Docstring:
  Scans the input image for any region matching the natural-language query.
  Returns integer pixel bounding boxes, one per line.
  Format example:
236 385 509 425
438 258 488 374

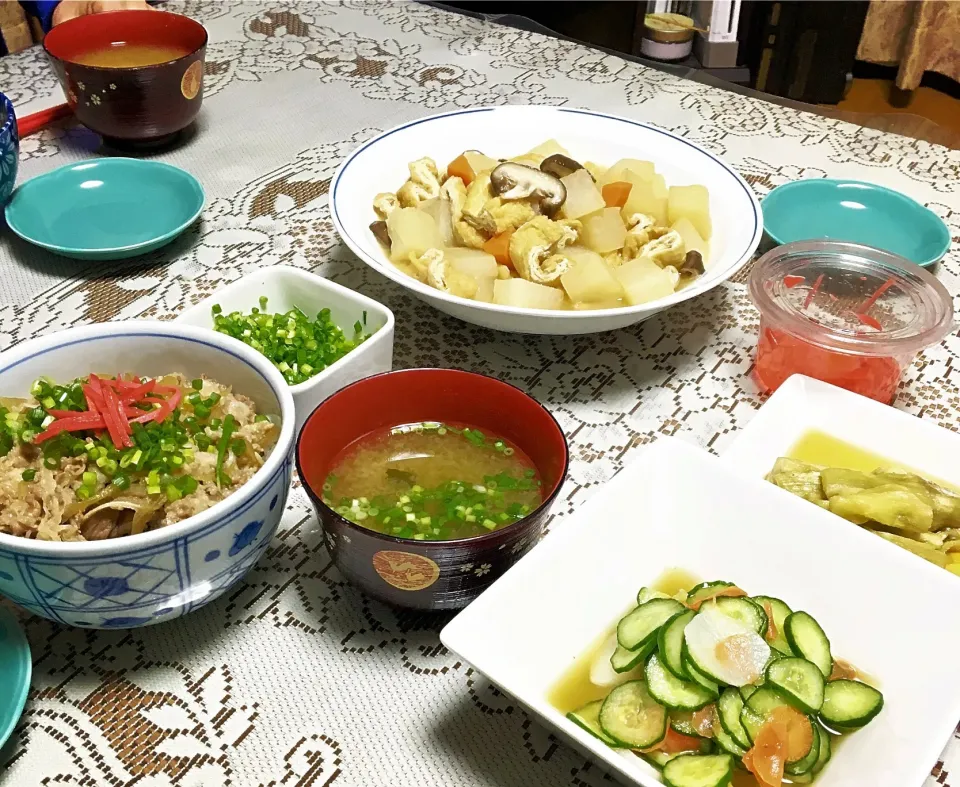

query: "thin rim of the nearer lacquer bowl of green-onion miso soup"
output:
293 366 570 549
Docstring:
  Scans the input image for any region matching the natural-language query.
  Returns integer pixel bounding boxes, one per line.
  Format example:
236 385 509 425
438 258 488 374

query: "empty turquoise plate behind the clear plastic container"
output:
760 179 950 266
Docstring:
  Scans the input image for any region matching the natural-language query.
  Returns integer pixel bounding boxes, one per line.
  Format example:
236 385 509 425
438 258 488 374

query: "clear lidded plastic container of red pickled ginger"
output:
750 241 953 403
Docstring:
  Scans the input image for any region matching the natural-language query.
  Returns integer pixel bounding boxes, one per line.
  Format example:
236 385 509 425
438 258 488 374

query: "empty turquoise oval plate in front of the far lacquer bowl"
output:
6 158 204 260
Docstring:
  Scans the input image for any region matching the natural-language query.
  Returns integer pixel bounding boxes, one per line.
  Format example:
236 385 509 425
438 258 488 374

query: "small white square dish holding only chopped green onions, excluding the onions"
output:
176 265 394 434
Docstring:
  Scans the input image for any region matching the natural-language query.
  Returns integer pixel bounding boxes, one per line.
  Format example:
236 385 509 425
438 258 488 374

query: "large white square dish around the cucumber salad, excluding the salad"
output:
440 438 960 787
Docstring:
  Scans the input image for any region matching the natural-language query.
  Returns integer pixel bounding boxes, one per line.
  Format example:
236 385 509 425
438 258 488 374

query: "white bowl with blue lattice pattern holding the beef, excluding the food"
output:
0 321 295 628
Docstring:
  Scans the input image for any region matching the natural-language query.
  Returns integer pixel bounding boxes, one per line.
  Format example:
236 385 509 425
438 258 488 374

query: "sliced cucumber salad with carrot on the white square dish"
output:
567 582 883 787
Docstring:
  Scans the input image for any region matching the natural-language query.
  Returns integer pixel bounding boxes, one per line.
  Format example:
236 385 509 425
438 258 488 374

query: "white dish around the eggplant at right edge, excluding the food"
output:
723 374 960 490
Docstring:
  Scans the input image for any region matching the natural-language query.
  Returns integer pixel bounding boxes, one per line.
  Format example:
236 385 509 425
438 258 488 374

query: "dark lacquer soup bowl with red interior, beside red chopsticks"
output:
43 10 207 144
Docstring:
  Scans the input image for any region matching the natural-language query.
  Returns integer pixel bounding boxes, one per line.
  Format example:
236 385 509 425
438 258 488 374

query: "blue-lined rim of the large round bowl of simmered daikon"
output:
330 104 763 321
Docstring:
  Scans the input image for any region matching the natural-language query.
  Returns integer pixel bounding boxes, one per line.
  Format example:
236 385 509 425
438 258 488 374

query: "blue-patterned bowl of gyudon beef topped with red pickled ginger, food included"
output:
0 322 294 628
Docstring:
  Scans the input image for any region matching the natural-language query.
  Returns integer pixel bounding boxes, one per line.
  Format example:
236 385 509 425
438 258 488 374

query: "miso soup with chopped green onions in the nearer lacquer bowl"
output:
323 422 543 541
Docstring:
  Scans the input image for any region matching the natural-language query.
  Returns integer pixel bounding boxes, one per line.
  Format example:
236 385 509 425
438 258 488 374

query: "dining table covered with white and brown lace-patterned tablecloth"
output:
0 0 960 787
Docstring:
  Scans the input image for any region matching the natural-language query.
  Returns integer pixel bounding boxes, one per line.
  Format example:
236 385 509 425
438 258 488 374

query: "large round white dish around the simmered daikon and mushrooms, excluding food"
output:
330 106 763 334
